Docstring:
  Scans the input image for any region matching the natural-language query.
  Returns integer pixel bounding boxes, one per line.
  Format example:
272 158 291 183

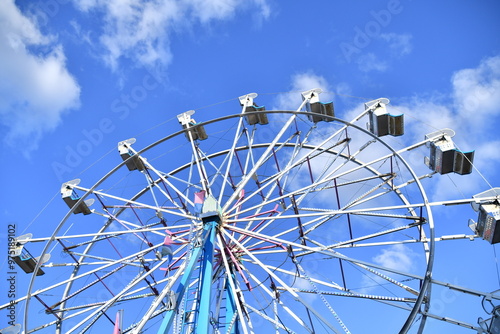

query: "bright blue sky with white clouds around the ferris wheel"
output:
0 0 500 332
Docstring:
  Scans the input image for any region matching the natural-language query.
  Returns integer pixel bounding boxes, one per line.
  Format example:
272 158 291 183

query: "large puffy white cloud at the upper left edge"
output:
0 0 80 154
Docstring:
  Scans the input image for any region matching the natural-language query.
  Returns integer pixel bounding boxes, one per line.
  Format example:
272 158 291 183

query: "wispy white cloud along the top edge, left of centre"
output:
72 0 270 70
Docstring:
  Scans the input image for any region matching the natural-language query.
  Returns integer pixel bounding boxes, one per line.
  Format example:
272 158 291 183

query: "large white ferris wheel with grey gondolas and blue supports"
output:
0 89 500 334
